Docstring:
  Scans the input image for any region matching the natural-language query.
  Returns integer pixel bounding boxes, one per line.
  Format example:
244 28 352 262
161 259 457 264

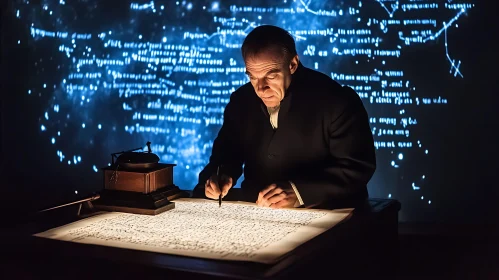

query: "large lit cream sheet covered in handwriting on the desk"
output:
35 198 353 263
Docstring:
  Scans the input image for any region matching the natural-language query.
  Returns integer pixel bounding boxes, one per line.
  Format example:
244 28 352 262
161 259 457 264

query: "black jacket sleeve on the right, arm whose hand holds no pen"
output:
292 87 376 205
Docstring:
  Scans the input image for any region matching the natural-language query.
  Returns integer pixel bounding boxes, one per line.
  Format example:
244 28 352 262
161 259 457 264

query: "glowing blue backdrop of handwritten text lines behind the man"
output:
6 0 488 223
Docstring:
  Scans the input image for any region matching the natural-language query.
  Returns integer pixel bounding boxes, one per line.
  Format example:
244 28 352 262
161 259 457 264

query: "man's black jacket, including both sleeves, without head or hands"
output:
194 63 376 205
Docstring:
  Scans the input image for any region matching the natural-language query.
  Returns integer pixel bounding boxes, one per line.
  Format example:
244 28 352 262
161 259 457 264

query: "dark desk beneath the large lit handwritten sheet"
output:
6 194 400 279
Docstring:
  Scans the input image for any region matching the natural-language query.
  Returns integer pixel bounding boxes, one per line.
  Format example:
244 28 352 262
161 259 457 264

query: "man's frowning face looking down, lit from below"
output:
245 50 298 107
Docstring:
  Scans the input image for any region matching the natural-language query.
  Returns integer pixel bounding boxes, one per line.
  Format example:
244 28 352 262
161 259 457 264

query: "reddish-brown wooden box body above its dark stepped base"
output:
103 163 175 194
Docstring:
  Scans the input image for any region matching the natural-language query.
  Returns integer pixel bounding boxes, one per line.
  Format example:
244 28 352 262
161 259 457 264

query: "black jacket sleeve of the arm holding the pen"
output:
193 92 243 198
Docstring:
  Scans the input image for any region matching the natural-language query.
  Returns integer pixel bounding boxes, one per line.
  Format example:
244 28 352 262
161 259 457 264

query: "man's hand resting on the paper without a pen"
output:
256 184 298 208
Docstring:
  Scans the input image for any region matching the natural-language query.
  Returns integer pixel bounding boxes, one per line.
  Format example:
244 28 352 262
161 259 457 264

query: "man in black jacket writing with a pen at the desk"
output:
193 25 376 208
